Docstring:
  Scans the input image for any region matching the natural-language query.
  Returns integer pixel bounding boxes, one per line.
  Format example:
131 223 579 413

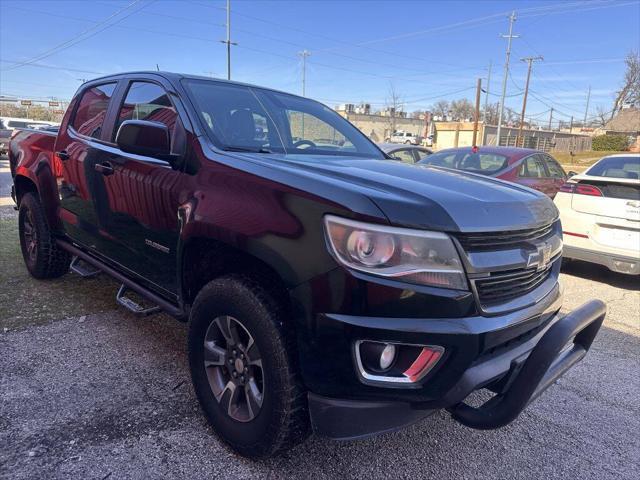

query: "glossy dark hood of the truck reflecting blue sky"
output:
251 154 558 232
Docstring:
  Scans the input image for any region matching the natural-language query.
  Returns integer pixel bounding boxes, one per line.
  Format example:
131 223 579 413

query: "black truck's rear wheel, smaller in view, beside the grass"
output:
18 192 71 279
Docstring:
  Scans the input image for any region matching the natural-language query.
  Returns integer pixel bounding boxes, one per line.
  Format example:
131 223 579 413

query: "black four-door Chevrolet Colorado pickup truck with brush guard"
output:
9 72 605 457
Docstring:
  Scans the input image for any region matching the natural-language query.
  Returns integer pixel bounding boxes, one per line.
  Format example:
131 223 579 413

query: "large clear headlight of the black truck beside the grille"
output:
324 215 467 290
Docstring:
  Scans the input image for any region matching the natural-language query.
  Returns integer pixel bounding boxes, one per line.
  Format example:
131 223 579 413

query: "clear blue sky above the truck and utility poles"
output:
0 0 640 124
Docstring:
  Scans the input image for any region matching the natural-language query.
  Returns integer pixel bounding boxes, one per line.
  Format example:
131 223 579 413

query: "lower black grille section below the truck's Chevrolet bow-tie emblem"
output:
473 262 554 306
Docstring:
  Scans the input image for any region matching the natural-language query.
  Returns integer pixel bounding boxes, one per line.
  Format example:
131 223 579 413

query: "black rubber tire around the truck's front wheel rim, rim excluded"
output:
188 275 310 458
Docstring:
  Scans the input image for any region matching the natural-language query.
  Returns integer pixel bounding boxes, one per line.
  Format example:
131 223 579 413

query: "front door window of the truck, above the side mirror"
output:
113 82 179 139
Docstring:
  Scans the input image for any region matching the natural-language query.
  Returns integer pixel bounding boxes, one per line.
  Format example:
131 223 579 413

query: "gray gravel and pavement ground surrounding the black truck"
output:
0 156 640 480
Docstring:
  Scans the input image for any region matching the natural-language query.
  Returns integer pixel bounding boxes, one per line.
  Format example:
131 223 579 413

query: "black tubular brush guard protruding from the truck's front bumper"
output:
447 300 606 430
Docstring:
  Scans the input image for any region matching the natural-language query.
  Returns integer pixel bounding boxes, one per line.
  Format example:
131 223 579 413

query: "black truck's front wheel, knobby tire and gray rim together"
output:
189 275 310 458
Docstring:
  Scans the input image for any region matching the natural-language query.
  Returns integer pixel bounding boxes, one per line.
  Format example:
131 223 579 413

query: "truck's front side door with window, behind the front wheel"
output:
93 79 186 294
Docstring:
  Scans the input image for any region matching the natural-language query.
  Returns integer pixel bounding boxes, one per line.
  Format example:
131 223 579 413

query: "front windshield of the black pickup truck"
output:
184 79 385 159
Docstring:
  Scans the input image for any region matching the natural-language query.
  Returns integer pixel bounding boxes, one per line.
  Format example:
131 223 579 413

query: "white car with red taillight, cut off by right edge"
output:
554 153 640 275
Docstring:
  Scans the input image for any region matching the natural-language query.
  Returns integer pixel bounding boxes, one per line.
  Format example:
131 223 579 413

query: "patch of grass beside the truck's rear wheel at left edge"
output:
0 207 118 332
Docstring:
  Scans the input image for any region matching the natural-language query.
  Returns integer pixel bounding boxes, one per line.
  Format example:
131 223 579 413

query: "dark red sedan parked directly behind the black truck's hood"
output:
420 147 567 198
